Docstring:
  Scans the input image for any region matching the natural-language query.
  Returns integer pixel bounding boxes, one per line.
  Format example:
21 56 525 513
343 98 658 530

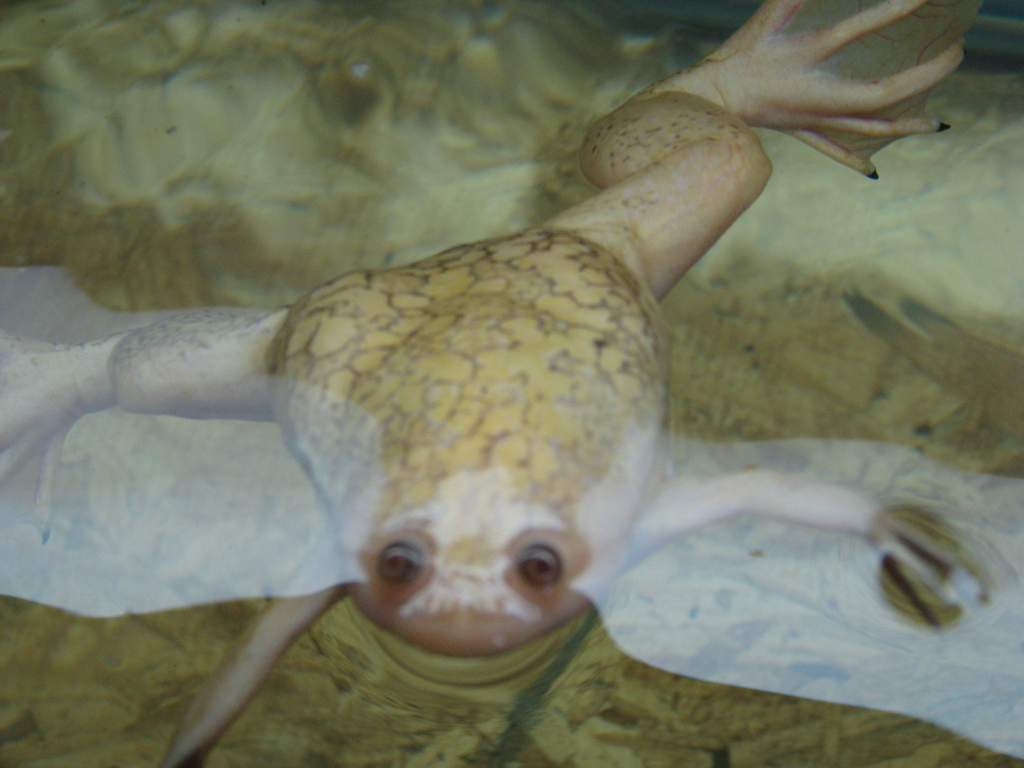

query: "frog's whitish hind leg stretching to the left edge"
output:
0 309 285 538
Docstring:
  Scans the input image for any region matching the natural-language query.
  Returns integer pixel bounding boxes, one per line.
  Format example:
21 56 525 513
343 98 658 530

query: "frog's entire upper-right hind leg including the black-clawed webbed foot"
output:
549 0 979 296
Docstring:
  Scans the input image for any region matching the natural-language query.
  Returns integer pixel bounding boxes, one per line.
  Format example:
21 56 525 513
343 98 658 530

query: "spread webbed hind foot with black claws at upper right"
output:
679 0 980 178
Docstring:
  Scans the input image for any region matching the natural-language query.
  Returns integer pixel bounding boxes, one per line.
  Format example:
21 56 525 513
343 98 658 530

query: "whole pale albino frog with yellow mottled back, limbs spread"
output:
0 0 979 766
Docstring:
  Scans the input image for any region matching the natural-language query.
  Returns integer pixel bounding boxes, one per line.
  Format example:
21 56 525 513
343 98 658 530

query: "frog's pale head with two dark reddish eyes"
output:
353 469 591 655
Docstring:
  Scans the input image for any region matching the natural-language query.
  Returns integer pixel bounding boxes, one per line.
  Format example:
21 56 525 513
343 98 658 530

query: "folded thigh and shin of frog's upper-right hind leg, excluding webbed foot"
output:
547 93 771 297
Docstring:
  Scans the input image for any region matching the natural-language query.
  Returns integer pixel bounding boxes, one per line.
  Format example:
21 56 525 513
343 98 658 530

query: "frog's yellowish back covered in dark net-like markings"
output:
271 230 666 524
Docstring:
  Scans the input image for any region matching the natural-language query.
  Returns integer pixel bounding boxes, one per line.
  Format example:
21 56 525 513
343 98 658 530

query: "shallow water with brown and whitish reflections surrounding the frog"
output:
0 0 1024 768
